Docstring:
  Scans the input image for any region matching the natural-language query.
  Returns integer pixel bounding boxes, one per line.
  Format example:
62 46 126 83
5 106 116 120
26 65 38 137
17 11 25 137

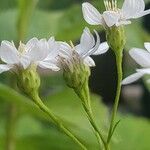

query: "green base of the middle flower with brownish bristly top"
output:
62 53 90 90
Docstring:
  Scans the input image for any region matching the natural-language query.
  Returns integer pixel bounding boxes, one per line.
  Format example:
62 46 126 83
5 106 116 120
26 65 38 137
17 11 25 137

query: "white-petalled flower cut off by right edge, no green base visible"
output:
122 42 150 85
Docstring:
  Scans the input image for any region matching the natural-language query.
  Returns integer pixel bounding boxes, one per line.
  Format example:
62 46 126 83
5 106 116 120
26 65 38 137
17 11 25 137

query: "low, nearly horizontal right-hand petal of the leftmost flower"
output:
38 61 60 71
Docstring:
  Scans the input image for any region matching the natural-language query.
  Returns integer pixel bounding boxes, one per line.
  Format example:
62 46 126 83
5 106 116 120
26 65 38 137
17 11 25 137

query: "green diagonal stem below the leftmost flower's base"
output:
34 96 87 150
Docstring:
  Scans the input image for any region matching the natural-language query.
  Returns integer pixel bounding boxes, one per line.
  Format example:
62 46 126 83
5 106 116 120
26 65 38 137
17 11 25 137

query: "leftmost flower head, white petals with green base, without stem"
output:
0 37 59 100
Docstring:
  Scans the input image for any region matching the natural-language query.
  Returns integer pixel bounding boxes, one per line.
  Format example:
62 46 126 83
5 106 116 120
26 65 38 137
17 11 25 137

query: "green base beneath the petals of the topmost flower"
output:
106 26 126 54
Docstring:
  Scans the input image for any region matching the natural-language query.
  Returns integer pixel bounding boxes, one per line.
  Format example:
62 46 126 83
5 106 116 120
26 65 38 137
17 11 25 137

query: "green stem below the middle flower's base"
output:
75 81 107 150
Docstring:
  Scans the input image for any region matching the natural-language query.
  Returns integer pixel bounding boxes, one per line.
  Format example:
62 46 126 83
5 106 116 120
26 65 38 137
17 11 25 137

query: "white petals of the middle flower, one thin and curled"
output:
60 27 109 67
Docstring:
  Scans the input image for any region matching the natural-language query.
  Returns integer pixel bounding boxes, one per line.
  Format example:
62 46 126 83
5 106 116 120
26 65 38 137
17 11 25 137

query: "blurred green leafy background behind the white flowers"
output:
0 0 150 150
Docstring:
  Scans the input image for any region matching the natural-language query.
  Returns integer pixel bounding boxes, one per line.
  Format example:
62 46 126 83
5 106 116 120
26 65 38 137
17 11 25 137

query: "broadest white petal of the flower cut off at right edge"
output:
129 48 150 67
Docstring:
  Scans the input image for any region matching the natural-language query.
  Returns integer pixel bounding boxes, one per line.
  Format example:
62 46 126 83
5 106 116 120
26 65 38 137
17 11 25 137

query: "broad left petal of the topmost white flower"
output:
82 2 103 25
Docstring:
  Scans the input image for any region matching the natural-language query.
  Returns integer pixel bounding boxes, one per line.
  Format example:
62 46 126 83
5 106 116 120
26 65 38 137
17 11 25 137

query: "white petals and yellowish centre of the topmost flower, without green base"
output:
82 0 150 27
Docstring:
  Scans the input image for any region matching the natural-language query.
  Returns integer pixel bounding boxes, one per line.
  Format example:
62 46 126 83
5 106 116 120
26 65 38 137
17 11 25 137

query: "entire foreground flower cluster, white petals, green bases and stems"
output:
0 0 150 150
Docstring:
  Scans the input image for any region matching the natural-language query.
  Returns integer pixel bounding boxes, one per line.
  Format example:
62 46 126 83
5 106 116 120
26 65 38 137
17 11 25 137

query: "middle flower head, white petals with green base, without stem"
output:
59 28 109 90
